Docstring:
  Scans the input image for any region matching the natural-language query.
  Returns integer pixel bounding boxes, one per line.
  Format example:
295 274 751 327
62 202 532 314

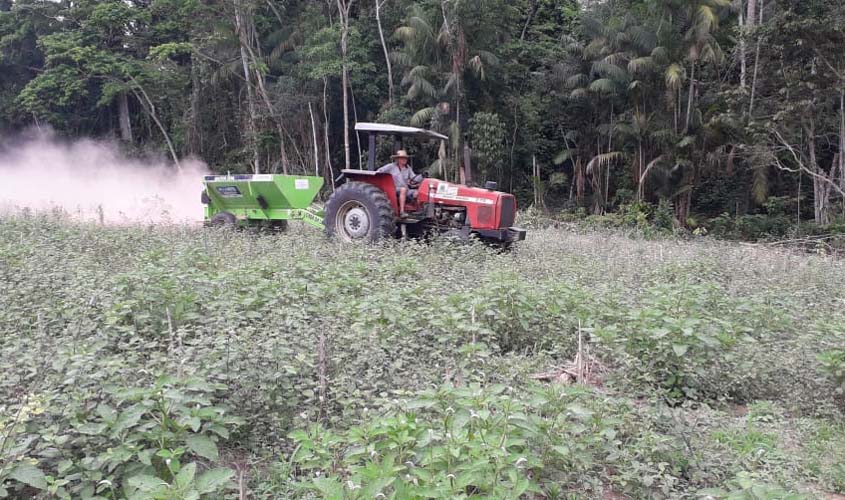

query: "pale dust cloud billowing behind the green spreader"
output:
0 133 208 224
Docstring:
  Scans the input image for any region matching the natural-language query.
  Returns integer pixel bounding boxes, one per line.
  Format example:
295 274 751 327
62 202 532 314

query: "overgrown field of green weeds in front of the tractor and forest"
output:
0 217 845 499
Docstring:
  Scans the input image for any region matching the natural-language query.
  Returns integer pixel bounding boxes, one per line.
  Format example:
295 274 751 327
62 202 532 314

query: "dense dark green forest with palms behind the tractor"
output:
0 0 845 226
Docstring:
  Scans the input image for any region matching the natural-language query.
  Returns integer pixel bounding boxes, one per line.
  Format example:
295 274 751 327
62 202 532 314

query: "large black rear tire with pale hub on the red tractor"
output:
324 182 396 242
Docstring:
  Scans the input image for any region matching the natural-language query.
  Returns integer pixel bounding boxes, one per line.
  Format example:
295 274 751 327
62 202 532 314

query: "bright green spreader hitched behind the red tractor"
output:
202 174 324 229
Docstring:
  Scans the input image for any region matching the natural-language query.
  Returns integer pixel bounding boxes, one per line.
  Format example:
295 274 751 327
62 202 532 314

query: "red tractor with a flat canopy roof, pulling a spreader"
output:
323 123 526 245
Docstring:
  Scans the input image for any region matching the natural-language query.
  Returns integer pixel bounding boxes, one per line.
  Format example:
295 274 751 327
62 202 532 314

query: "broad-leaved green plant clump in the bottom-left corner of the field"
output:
0 376 243 499
